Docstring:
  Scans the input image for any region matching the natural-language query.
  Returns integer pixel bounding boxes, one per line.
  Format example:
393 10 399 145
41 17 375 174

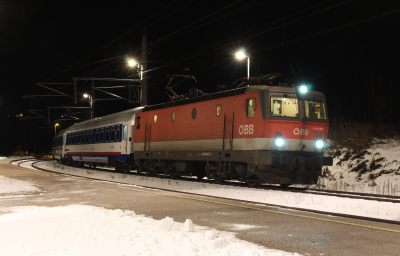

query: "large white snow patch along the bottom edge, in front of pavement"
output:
0 205 299 256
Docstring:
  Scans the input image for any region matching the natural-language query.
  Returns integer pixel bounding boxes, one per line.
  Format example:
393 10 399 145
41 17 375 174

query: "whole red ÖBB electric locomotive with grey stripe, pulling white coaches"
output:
133 74 333 185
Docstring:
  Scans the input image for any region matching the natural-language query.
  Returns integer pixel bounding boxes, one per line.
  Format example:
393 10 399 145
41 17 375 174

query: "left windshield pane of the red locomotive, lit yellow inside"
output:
271 97 299 117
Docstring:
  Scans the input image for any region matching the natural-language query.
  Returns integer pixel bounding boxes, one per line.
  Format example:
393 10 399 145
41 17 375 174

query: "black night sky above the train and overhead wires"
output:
0 0 400 154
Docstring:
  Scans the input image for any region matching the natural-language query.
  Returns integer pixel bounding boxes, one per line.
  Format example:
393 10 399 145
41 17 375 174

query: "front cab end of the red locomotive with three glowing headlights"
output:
249 86 333 185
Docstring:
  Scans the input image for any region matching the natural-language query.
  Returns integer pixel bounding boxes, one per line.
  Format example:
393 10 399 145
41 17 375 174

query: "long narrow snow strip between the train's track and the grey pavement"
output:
37 162 400 221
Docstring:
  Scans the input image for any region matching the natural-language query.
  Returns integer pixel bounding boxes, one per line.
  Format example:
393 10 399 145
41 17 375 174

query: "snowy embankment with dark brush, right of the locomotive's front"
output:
316 140 400 196
